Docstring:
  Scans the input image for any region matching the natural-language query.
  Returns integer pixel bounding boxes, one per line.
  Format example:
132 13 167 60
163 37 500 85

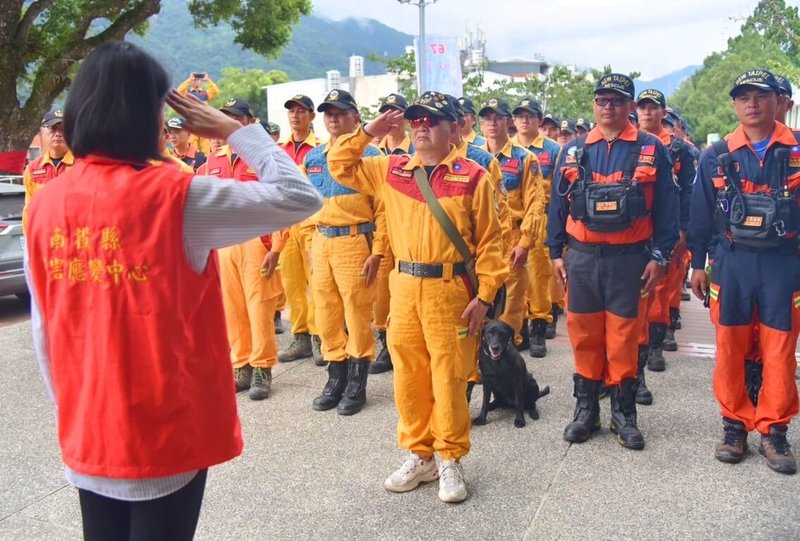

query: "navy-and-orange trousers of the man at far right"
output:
709 246 800 434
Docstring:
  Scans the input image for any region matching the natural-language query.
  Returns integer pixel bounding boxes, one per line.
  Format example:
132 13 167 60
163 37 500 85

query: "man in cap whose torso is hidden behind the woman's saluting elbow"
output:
278 94 325 366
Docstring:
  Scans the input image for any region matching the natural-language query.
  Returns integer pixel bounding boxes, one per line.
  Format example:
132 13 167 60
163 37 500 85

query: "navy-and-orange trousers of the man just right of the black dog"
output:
564 249 647 386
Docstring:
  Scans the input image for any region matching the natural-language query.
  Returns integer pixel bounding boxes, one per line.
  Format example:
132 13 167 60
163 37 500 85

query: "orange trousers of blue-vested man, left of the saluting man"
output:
311 231 376 362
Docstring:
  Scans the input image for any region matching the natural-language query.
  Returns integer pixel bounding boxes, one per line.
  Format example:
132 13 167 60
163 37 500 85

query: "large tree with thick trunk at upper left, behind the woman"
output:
0 0 311 160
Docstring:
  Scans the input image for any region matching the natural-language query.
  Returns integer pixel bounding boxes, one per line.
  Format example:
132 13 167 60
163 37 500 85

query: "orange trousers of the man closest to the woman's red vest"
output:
218 238 283 368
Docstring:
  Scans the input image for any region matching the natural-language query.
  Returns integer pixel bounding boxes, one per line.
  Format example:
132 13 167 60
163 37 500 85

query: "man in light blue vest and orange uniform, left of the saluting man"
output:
303 90 386 415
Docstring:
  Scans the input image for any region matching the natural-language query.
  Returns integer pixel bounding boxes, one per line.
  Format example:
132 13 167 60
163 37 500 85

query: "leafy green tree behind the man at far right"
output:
669 0 800 142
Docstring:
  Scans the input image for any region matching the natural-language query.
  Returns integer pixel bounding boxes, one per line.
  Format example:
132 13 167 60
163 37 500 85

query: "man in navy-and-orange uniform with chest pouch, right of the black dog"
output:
547 73 678 449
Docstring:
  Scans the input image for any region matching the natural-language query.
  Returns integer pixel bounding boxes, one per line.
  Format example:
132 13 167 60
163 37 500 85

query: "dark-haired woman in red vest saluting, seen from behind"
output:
26 42 322 540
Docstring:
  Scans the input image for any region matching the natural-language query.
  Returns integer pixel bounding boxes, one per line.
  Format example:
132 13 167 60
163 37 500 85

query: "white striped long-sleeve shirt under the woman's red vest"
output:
25 124 322 501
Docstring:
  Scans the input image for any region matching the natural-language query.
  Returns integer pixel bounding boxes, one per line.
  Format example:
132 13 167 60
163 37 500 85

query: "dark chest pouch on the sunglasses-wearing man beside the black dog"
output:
569 182 649 233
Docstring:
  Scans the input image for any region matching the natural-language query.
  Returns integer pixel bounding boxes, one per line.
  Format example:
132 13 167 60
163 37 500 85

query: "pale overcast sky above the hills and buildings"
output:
313 0 800 80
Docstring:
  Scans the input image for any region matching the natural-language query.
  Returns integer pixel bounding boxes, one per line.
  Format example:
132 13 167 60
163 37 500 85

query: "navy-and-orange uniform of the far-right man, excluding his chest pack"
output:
687 122 800 434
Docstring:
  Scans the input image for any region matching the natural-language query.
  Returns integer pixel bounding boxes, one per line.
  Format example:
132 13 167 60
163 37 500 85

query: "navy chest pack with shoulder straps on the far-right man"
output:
713 140 800 251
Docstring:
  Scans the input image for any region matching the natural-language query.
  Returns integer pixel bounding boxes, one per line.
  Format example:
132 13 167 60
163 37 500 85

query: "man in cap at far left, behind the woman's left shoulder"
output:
22 109 75 225
